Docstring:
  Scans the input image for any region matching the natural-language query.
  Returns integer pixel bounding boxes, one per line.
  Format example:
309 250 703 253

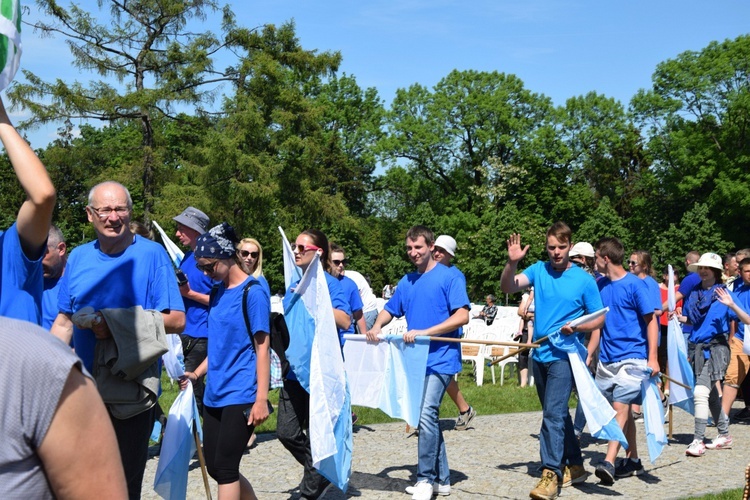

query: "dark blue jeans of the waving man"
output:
534 359 583 478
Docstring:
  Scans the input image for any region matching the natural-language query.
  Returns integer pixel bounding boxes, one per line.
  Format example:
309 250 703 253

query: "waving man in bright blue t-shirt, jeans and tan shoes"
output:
500 222 604 499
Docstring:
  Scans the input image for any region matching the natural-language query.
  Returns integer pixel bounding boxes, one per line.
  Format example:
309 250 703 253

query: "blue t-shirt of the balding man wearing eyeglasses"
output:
57 235 185 373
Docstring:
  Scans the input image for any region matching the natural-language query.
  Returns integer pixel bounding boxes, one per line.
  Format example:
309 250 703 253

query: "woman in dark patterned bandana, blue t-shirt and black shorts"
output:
180 223 271 499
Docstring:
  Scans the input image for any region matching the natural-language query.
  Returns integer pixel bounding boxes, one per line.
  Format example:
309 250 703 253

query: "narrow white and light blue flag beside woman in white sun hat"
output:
667 266 695 415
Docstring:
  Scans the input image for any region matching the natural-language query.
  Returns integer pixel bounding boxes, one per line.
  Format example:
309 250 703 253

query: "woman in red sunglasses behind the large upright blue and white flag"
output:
276 229 352 498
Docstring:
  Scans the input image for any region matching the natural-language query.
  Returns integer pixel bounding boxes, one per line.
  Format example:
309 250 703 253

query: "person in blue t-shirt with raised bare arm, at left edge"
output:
0 100 56 325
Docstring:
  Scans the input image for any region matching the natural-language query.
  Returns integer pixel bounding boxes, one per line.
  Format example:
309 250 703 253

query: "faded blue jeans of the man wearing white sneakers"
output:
417 373 452 484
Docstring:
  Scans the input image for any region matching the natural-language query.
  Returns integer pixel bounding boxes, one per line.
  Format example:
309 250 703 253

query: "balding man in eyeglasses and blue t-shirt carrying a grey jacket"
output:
50 181 185 499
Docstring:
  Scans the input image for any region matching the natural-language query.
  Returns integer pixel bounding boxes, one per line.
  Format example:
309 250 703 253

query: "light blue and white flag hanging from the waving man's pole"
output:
548 330 628 449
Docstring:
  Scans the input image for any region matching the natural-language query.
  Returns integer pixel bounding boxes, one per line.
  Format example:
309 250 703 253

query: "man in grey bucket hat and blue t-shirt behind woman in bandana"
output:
172 207 213 414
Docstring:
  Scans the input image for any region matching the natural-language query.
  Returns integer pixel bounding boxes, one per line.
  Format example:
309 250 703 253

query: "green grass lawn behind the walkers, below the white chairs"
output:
159 363 575 432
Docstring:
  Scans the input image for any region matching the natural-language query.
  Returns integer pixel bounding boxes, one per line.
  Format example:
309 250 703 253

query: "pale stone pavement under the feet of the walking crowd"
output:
143 405 750 500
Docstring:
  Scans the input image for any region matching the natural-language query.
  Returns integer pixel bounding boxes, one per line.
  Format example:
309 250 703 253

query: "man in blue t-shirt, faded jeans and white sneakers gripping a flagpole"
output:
367 226 469 500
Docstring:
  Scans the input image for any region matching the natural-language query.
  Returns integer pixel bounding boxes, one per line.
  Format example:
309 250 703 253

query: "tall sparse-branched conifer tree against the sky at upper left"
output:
8 0 234 221
